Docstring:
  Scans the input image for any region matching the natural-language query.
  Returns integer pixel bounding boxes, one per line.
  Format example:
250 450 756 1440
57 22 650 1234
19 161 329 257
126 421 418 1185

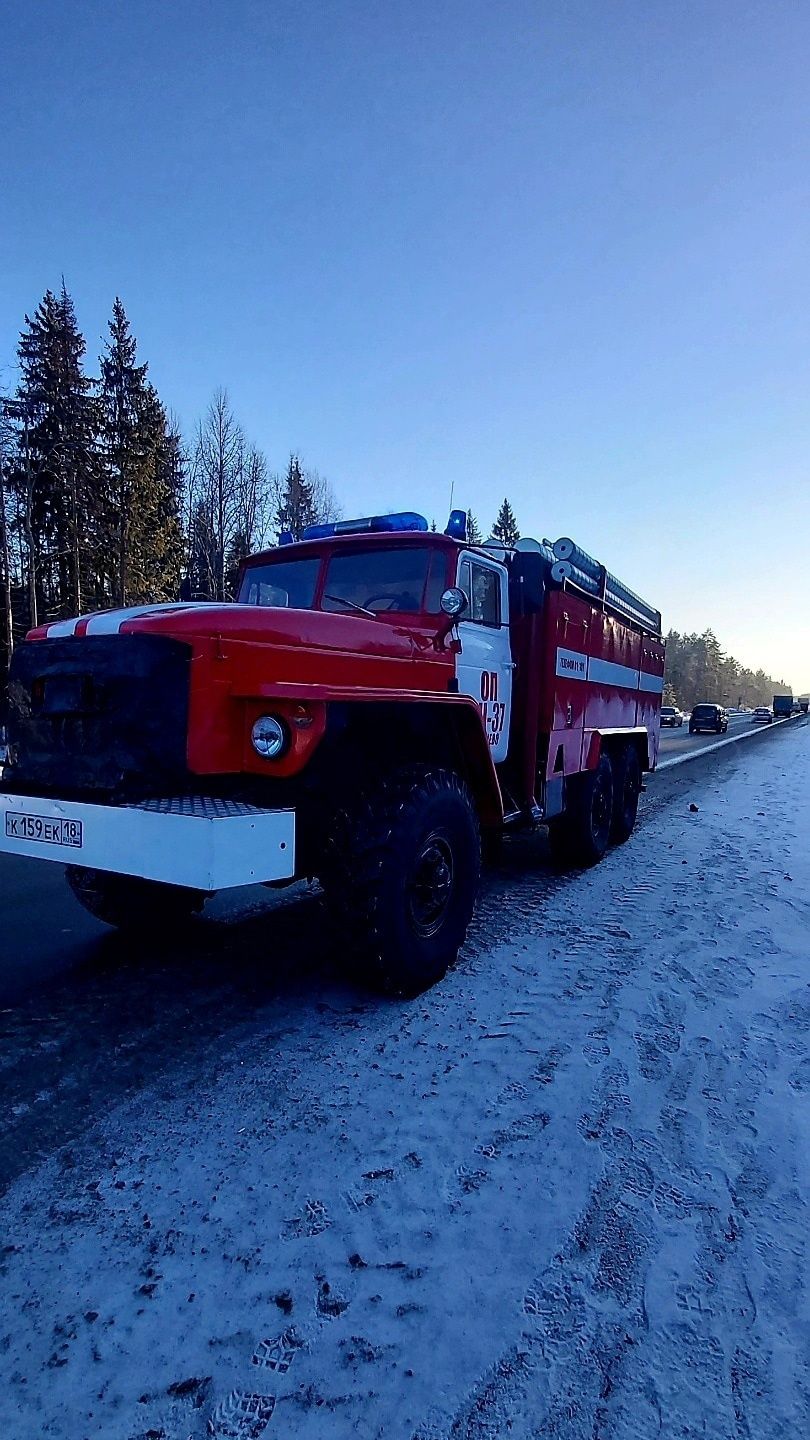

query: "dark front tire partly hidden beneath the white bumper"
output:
65 865 205 933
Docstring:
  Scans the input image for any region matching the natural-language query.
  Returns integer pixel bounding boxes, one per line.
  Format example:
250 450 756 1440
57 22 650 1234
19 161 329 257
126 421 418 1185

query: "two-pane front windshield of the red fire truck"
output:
239 546 445 615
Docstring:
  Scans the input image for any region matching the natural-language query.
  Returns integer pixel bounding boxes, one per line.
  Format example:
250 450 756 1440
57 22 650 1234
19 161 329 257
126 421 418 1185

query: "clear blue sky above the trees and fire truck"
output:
0 0 810 690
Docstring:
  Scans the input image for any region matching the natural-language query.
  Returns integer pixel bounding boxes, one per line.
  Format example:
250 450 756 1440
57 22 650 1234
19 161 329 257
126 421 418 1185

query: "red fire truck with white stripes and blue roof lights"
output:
0 511 664 994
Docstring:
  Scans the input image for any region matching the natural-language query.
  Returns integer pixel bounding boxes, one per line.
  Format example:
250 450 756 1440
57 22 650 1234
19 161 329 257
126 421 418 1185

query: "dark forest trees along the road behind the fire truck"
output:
0 284 788 706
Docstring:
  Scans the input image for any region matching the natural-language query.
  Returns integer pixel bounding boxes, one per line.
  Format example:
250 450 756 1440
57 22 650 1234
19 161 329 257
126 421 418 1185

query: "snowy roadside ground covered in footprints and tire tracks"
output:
0 726 810 1440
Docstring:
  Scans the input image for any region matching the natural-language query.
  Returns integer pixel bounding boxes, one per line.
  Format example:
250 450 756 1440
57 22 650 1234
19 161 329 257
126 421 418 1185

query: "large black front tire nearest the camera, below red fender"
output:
320 765 481 996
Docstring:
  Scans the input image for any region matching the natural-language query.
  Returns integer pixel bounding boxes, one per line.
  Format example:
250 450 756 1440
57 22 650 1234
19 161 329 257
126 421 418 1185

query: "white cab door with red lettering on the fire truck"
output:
455 554 515 765
